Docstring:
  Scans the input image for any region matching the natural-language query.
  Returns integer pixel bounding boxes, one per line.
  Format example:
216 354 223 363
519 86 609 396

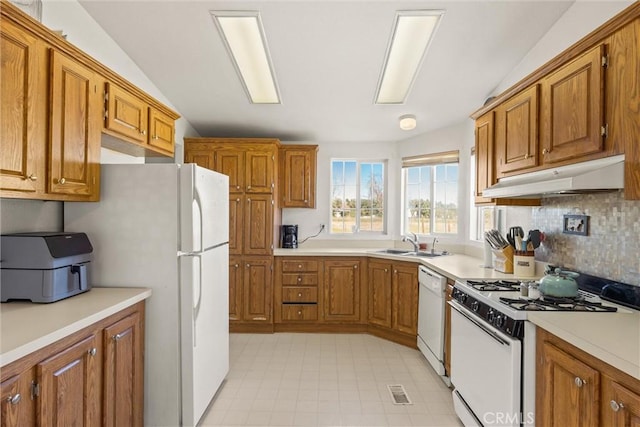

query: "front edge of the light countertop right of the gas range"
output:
528 313 640 380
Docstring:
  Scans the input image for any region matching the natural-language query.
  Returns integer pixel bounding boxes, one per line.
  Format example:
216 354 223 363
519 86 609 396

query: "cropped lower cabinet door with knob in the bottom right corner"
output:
602 378 640 427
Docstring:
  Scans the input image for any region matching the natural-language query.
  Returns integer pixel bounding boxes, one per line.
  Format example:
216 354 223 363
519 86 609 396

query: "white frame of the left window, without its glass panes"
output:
329 157 389 236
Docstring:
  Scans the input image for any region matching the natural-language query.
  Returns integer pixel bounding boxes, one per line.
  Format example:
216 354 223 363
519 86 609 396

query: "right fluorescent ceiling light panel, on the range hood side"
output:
375 10 444 104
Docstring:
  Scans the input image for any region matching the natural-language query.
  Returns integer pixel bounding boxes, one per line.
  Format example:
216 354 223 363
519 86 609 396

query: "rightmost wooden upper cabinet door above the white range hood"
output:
542 45 604 163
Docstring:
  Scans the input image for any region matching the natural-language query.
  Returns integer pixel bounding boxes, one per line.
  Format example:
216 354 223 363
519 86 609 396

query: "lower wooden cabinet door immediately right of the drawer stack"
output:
324 260 361 322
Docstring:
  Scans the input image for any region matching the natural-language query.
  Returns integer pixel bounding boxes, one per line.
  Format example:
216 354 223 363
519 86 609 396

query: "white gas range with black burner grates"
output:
449 275 635 426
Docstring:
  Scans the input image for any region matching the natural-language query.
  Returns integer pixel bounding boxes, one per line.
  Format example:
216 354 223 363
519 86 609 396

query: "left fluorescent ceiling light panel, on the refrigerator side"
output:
210 11 280 104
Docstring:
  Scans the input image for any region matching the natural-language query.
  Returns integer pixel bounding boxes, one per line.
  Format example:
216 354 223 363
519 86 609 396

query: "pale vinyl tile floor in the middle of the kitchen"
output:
199 333 462 427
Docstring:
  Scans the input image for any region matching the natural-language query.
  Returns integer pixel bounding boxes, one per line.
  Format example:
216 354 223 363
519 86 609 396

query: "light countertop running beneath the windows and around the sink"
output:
274 248 542 280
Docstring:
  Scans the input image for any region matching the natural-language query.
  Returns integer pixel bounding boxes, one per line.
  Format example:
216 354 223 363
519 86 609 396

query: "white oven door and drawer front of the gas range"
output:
449 300 522 426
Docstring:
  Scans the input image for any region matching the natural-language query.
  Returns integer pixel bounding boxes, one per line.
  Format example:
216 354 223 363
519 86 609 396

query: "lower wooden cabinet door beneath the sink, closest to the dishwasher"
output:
392 264 418 335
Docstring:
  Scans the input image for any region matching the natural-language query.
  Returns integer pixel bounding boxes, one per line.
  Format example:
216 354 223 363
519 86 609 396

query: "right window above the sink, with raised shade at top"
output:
402 151 458 234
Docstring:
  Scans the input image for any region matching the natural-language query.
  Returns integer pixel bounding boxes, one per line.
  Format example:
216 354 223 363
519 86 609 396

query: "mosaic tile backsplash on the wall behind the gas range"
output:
532 191 640 286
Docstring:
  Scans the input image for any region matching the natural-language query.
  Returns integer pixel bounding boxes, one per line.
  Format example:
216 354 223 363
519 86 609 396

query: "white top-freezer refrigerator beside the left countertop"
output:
64 164 229 426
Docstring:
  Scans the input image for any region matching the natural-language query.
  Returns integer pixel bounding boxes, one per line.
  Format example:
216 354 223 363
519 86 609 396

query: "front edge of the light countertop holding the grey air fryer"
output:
0 288 151 367
